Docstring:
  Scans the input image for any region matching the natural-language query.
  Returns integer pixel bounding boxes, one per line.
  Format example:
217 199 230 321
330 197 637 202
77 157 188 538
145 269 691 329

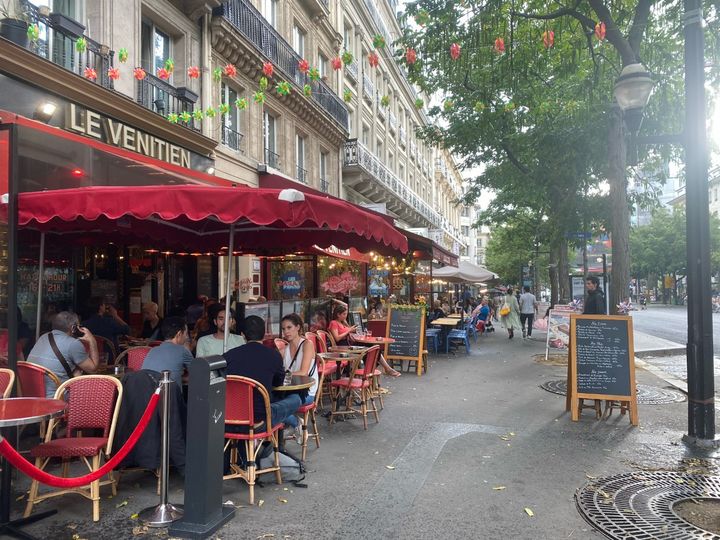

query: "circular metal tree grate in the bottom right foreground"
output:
575 472 720 540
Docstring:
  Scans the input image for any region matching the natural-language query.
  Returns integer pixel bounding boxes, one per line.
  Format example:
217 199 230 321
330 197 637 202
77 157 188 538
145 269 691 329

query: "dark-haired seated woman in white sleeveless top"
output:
280 313 318 444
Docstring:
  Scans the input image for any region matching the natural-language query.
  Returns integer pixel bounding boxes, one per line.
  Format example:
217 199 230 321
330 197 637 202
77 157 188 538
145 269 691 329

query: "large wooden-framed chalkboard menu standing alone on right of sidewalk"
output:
568 315 638 426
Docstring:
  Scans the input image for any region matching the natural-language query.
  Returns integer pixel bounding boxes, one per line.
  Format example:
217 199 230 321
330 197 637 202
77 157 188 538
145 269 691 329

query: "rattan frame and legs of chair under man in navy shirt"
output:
223 375 282 504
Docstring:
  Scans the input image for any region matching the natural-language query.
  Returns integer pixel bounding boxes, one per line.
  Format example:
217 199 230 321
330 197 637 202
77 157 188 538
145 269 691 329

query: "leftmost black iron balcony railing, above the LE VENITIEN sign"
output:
23 2 114 90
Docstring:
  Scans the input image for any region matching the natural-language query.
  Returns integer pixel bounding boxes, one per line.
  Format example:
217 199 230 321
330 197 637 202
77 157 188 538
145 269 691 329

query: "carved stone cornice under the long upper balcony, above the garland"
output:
211 17 347 146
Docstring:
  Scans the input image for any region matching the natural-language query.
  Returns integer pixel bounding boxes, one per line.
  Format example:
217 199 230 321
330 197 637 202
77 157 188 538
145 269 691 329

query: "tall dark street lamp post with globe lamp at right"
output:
615 4 718 446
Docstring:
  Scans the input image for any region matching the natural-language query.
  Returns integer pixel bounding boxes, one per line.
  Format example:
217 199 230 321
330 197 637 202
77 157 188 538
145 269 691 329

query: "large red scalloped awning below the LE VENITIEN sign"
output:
4 186 408 255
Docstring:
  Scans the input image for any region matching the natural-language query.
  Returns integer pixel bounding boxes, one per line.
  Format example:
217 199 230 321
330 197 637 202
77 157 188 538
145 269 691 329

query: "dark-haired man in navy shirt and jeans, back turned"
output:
225 315 301 429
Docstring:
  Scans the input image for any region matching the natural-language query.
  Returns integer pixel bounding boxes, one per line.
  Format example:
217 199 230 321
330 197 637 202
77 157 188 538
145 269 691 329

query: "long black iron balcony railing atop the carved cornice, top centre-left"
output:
213 0 348 131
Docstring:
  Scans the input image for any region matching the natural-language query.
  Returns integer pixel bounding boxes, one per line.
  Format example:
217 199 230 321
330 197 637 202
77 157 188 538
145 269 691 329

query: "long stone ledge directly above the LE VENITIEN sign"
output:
0 38 218 156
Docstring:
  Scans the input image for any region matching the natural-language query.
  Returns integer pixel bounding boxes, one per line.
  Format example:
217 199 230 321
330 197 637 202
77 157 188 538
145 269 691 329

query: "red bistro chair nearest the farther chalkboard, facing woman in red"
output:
330 345 380 429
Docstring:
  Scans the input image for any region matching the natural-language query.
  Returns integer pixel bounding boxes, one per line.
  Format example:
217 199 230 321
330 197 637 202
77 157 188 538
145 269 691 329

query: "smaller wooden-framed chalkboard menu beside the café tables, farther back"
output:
385 305 425 377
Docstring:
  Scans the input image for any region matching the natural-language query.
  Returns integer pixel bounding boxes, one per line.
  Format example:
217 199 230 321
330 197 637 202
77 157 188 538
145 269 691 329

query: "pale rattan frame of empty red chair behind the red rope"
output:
24 375 123 521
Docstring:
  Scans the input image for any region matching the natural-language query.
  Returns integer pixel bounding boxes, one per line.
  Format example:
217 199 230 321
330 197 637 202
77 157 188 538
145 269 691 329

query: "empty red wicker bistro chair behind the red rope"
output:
25 375 123 521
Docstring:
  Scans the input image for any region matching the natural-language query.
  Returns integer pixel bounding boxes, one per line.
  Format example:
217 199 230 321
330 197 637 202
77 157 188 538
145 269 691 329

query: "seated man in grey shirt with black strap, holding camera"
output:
28 311 99 398
